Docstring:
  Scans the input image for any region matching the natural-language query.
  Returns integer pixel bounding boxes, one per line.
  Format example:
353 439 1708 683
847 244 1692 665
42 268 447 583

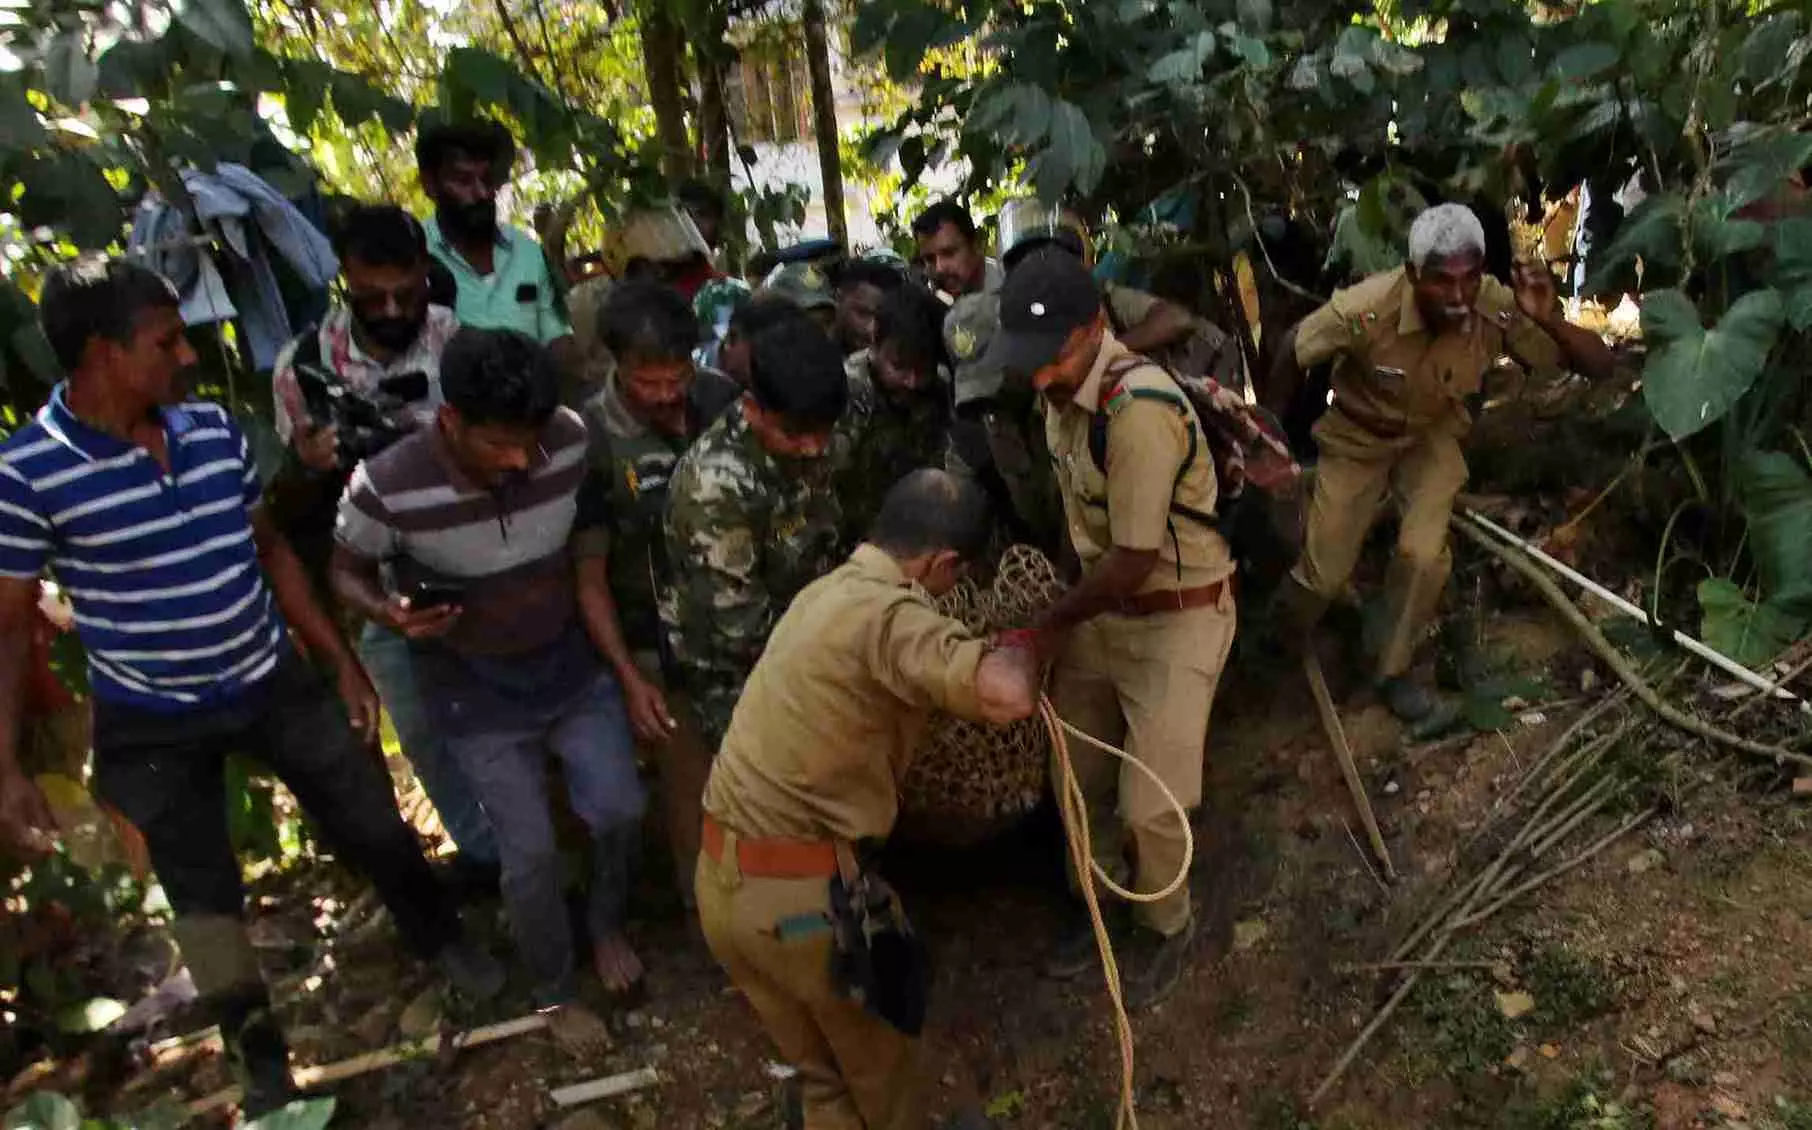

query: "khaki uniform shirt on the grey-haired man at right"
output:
1296 266 1560 445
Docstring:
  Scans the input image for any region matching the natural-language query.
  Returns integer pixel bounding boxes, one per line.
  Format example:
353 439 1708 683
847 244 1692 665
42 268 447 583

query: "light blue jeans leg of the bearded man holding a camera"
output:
359 623 498 867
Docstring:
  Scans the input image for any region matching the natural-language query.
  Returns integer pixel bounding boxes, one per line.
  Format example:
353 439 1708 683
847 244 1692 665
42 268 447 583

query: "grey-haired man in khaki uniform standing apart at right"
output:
1265 205 1614 723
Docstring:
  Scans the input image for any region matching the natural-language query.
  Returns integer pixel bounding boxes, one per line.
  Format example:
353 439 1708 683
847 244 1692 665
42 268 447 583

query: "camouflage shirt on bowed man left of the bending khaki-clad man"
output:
661 406 839 748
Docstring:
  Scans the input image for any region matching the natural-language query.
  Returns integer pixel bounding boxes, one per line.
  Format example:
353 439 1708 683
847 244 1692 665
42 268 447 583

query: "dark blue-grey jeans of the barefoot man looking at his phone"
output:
448 672 643 1007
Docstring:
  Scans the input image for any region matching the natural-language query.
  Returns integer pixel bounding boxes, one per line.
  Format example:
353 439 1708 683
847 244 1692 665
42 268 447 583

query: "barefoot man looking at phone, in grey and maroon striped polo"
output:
333 328 669 1054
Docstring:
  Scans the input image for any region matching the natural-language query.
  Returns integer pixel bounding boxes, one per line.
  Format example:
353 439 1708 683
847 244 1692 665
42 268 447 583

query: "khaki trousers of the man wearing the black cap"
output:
1051 587 1238 936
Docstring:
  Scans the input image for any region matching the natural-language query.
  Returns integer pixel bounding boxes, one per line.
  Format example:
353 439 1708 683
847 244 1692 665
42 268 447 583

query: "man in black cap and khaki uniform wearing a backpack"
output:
989 250 1236 1007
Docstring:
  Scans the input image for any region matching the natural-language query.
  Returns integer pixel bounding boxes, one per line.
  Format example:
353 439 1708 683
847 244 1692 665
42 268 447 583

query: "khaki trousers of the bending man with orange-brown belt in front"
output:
698 833 924 1130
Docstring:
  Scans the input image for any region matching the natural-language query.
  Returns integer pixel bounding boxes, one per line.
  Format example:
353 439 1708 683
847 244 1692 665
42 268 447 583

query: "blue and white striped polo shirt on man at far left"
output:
0 386 284 712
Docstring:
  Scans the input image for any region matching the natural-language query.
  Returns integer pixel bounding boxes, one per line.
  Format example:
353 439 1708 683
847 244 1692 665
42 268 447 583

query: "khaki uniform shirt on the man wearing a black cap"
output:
1044 333 1234 592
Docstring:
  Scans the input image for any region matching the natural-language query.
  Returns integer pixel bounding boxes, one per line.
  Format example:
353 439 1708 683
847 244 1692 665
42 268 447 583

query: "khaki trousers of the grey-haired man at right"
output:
1296 420 1466 679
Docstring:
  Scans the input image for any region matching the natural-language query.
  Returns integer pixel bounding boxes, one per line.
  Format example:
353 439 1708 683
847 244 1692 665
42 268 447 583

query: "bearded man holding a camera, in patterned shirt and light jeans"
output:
272 205 498 887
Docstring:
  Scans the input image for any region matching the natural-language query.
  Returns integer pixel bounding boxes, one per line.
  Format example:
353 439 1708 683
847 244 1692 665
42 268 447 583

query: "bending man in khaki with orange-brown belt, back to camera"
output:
698 471 1038 1130
